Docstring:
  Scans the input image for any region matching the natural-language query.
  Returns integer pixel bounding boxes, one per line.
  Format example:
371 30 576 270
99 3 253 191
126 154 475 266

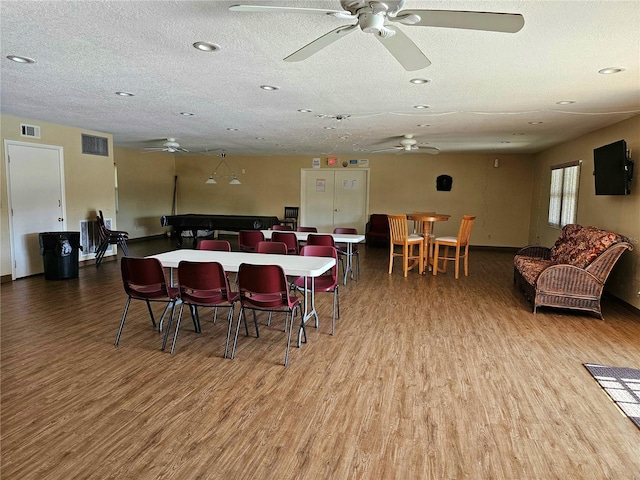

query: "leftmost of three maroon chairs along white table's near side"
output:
115 257 179 346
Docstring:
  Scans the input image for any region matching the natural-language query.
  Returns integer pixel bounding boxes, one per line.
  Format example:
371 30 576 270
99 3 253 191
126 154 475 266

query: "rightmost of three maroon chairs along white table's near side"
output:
227 263 307 366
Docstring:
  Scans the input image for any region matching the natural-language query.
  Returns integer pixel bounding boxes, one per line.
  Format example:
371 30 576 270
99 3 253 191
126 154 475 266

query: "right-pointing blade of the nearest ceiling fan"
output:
400 10 524 33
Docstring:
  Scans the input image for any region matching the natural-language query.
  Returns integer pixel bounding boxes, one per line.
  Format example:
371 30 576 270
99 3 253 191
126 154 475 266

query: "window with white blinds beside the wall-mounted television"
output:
549 162 580 228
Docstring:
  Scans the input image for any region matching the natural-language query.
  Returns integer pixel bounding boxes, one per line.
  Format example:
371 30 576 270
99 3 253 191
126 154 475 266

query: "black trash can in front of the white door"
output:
40 232 82 280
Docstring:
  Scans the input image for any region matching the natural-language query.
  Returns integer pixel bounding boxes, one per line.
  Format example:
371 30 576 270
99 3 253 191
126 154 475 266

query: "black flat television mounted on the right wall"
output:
593 140 633 195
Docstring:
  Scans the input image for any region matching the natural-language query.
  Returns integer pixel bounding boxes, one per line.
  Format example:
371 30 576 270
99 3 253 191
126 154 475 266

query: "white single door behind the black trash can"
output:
5 140 66 279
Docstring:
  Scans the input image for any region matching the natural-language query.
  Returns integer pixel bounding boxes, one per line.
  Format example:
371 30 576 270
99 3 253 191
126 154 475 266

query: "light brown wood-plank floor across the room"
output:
1 240 640 480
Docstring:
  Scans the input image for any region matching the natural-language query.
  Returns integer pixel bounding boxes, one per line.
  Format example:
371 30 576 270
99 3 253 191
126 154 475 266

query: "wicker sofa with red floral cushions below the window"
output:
513 224 633 319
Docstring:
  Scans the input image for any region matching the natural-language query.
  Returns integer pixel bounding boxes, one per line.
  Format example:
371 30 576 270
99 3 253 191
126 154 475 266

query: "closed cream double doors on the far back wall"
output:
299 168 369 233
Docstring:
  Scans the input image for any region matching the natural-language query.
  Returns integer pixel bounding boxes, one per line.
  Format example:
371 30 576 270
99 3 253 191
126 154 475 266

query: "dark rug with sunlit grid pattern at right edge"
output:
584 363 640 428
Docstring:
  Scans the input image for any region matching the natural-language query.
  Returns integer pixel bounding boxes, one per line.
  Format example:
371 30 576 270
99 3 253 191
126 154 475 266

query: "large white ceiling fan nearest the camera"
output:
229 0 524 71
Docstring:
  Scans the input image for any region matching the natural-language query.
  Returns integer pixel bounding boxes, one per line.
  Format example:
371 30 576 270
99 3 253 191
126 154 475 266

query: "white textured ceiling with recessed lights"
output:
0 0 640 158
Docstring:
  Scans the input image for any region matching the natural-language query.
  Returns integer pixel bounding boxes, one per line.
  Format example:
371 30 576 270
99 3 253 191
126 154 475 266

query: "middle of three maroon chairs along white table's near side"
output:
162 260 238 358
